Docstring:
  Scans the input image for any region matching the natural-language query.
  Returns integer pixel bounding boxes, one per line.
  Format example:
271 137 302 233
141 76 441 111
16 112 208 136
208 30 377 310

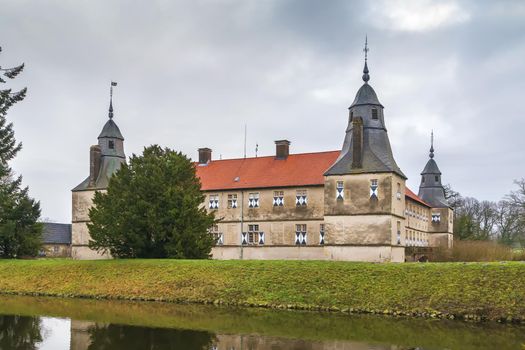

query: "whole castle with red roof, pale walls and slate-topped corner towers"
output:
72 48 453 262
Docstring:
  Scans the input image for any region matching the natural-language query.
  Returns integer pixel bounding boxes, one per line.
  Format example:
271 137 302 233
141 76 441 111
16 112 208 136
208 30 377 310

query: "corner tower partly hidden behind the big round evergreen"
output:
71 82 126 259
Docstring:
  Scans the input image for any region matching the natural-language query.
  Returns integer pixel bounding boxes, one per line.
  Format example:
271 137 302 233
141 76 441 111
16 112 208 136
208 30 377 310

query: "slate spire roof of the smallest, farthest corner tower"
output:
418 132 449 208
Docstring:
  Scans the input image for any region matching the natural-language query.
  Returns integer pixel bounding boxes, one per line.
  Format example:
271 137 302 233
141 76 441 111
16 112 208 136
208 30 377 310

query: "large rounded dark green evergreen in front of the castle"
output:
88 145 215 259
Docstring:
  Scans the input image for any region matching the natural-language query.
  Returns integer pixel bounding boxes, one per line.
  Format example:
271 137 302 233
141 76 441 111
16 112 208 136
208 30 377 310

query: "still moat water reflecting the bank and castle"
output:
0 295 525 350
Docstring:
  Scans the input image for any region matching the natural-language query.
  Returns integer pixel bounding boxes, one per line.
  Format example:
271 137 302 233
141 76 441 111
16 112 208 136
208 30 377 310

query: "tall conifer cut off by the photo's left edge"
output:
0 48 42 258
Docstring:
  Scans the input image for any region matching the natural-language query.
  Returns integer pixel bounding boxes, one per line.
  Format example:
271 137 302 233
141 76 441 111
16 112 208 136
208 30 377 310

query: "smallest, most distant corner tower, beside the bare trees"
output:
418 132 454 248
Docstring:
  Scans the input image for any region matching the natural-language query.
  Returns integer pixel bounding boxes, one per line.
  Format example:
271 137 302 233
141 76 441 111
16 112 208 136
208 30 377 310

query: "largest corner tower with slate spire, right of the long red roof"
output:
324 41 406 262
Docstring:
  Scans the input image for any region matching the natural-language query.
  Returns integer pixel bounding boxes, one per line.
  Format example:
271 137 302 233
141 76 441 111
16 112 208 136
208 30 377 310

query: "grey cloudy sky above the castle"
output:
0 0 525 222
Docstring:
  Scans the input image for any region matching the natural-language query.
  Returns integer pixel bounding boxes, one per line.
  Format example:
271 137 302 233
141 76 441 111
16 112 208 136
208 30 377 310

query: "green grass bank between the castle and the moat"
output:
0 260 525 322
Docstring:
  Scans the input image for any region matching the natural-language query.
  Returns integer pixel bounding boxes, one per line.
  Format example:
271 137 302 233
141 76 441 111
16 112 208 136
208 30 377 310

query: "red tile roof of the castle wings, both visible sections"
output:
196 151 430 207
